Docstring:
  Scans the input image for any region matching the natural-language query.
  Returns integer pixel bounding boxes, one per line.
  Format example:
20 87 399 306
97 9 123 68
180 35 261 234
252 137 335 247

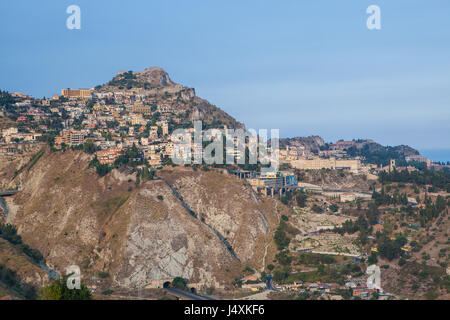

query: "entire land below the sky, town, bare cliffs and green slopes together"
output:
0 68 450 299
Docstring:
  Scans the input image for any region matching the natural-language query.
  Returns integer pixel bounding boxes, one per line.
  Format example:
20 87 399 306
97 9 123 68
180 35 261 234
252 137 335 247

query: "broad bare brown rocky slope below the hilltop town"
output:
7 150 278 289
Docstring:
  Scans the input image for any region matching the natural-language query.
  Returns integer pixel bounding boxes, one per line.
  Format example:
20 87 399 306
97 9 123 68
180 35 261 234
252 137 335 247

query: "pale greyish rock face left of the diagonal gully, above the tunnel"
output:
107 181 241 288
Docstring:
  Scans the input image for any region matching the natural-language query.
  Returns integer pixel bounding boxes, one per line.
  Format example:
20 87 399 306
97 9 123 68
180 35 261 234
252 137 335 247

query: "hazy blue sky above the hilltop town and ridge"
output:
0 0 450 161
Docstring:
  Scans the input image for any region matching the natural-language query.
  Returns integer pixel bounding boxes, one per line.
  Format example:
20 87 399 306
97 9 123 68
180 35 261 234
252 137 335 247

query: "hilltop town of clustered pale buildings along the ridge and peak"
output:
0 68 445 179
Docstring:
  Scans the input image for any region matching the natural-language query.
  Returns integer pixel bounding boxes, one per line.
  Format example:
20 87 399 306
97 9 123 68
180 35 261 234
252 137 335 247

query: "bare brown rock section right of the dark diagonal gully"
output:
161 168 277 269
